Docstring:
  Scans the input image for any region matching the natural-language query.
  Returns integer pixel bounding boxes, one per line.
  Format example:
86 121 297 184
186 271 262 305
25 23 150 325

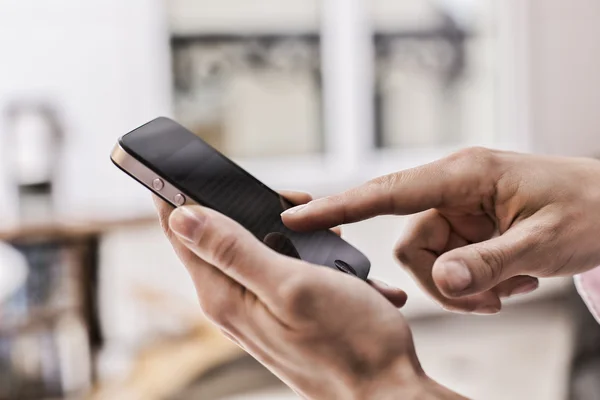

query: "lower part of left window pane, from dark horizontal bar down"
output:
173 35 322 157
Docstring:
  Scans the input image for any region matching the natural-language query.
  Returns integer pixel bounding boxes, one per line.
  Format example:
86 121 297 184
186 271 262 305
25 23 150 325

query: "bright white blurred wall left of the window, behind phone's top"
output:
0 0 171 223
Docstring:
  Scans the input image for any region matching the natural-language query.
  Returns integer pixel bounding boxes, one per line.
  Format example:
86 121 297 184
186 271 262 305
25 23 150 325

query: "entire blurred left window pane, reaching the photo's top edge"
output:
170 0 324 157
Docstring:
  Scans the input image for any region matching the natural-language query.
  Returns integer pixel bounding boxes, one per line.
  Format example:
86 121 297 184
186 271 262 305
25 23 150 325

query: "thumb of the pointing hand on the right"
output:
432 227 540 297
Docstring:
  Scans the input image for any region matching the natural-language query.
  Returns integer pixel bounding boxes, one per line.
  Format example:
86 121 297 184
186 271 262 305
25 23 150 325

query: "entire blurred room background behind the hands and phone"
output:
0 0 600 400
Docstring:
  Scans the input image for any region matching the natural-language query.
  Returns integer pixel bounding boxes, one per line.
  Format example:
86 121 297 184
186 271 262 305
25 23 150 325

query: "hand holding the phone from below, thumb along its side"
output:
156 192 457 399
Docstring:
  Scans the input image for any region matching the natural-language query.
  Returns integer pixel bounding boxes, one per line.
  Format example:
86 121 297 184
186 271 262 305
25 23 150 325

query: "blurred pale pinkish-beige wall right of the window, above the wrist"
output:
528 0 600 155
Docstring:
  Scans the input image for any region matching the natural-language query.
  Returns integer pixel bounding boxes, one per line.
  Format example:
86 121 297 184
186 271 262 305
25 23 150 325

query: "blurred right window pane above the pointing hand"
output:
373 0 496 148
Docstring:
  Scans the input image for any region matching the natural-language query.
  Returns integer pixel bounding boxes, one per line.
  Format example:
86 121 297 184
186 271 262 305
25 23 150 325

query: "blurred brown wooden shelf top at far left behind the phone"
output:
0 214 158 241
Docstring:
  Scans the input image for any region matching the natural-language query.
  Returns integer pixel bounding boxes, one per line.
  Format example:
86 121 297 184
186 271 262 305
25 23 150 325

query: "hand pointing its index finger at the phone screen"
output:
282 148 600 314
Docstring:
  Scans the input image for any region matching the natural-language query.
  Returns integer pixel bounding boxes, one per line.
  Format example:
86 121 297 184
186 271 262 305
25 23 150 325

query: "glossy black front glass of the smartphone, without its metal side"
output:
123 120 331 262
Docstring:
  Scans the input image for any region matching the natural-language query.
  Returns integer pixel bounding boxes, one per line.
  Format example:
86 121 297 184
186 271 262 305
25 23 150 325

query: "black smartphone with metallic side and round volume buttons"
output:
111 117 371 279
